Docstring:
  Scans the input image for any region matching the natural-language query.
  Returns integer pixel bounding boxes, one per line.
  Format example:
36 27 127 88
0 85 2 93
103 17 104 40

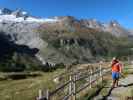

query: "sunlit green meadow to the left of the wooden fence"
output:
0 69 64 100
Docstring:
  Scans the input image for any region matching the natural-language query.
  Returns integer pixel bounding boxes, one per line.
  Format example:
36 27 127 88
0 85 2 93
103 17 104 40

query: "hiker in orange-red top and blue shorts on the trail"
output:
111 57 122 88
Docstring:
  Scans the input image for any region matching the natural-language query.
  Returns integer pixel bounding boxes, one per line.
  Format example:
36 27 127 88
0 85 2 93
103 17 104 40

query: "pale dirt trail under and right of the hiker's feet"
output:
106 75 133 100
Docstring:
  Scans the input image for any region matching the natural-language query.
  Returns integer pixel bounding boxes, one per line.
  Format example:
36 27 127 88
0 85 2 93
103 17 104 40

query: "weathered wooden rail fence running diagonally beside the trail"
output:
37 64 111 100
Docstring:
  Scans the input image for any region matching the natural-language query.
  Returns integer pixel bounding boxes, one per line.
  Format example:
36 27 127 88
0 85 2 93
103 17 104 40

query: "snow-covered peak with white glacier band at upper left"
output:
0 8 58 23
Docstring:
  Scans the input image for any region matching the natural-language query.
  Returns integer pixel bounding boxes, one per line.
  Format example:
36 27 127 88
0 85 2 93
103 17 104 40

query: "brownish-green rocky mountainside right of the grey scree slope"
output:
38 16 132 63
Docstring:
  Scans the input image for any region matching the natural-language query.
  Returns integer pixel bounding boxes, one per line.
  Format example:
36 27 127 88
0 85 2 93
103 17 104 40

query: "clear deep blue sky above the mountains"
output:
0 0 133 28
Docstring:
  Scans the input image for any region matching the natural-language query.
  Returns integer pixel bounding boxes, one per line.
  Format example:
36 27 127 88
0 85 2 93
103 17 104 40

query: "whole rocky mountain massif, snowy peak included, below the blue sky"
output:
0 8 132 69
